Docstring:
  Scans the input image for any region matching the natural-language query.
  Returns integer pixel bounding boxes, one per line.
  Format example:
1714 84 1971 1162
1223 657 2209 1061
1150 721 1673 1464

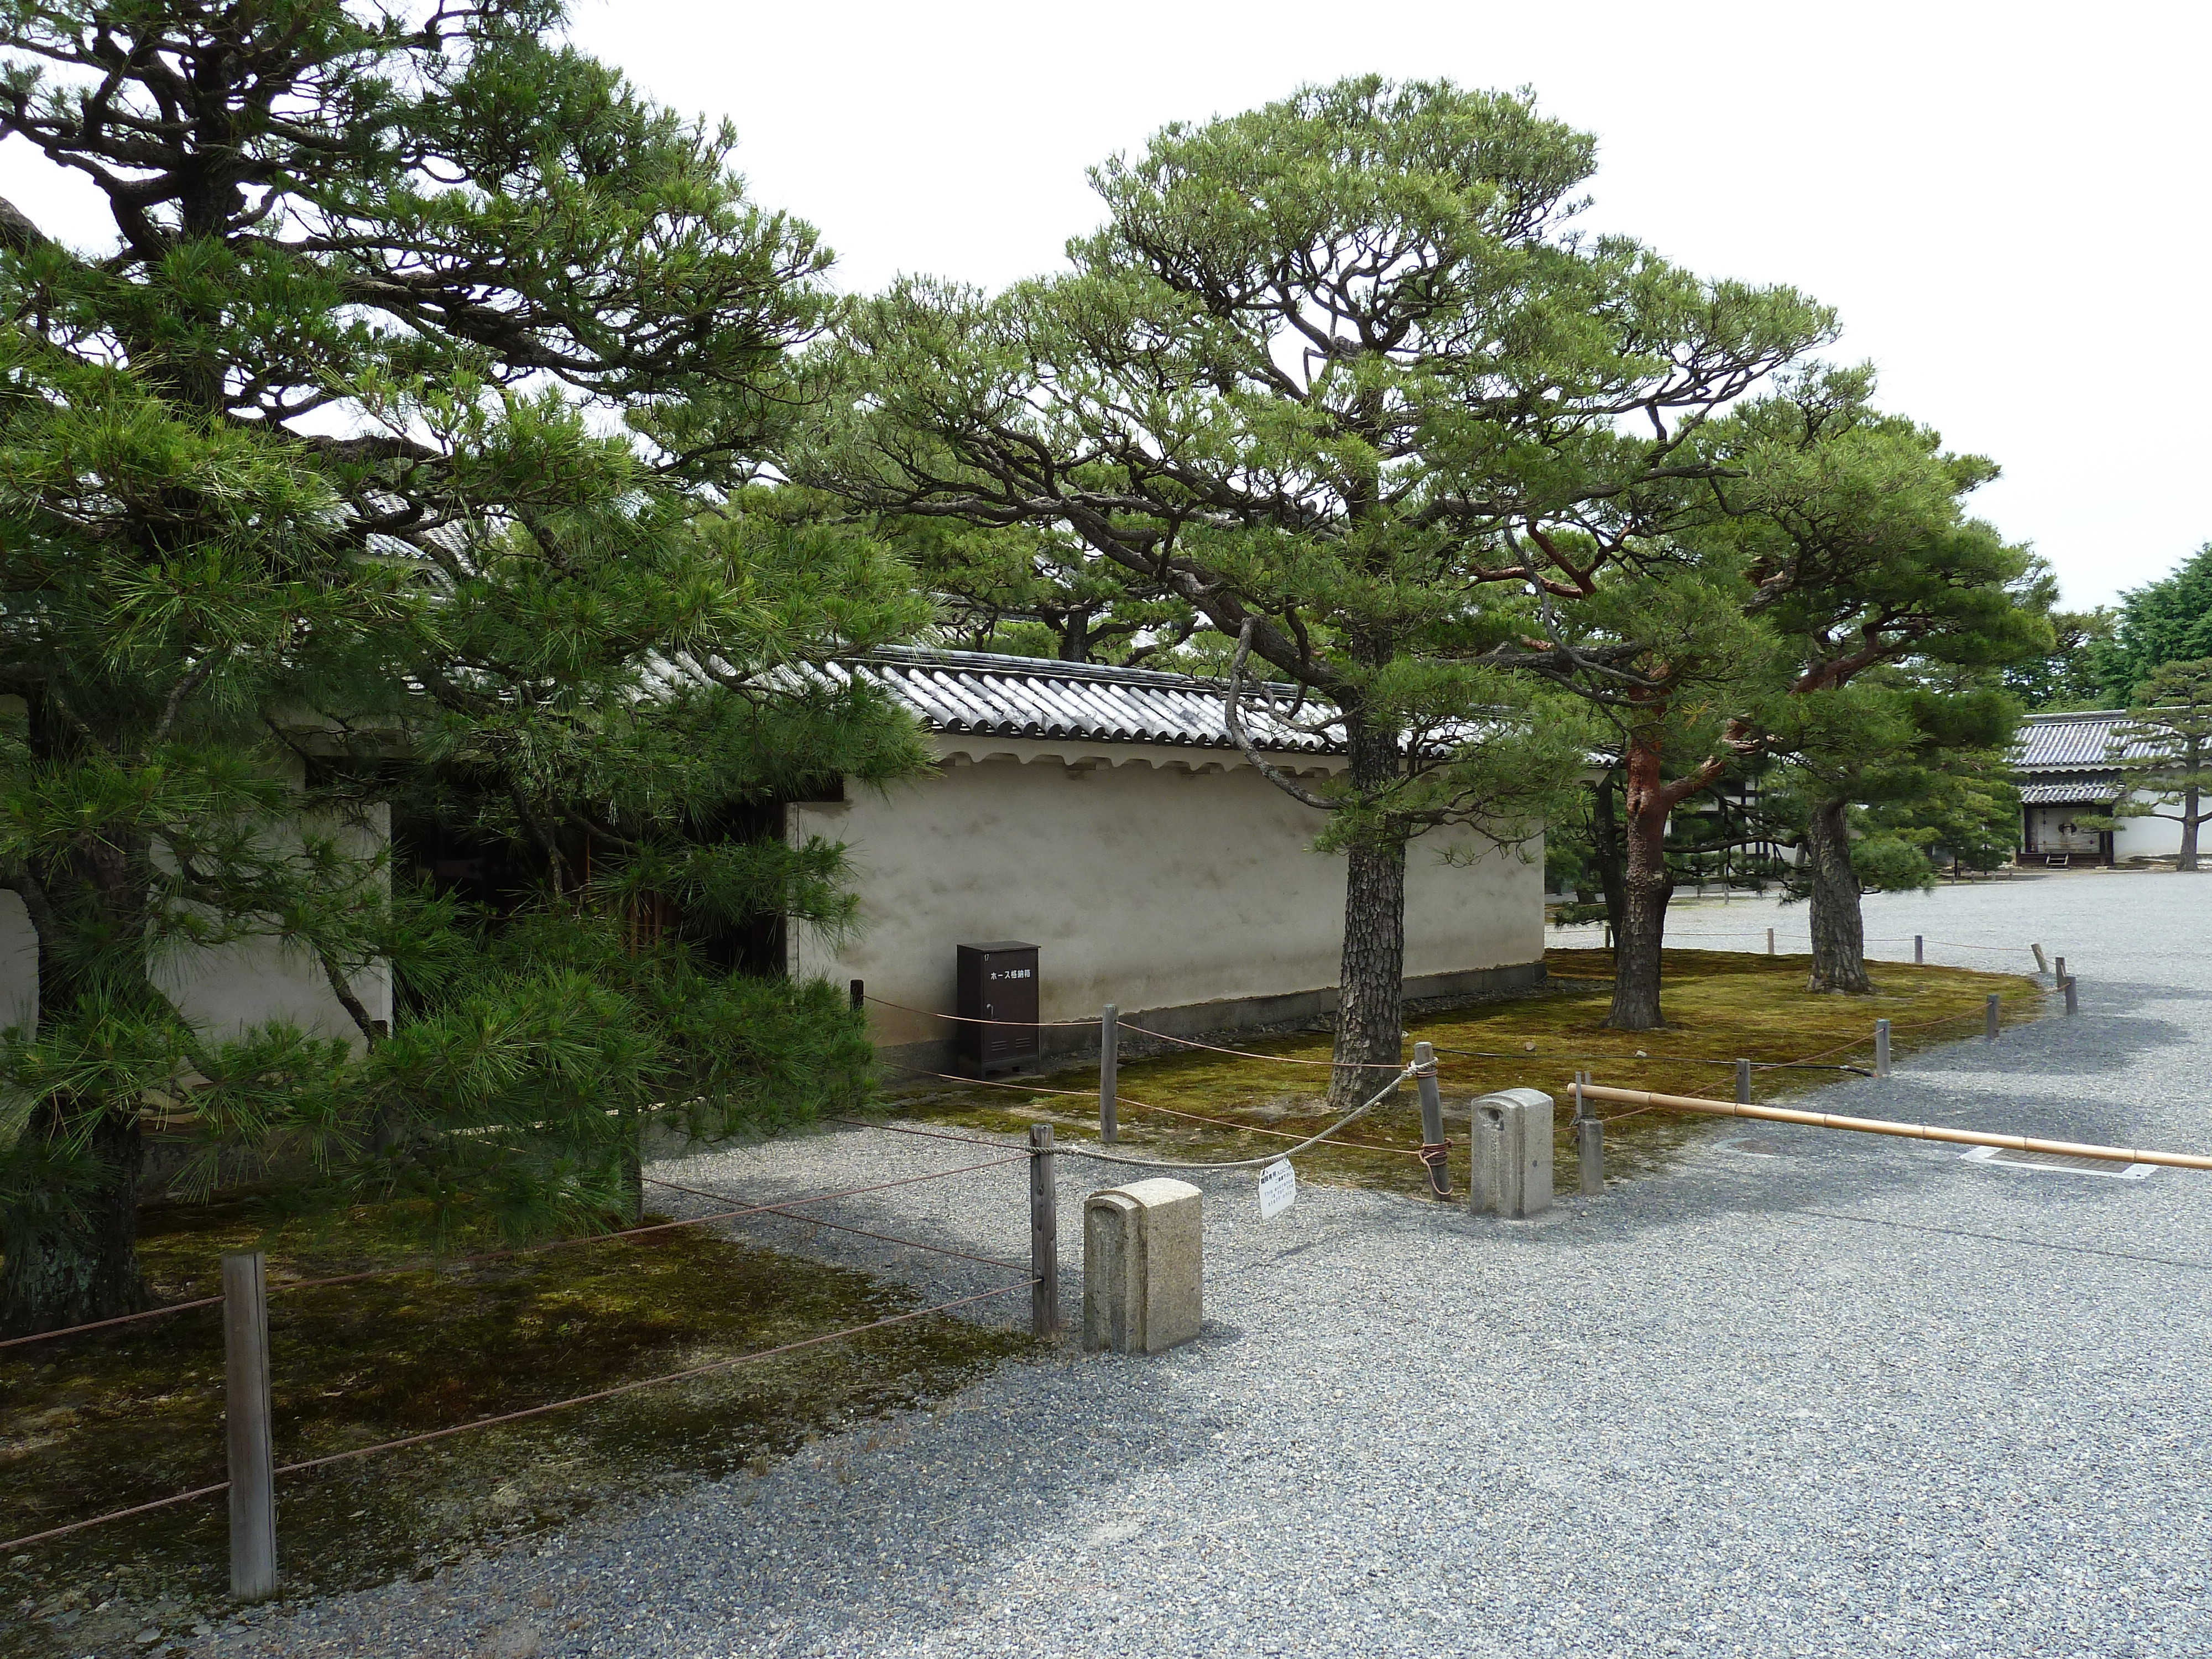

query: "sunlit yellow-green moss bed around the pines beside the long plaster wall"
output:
876 951 2044 1194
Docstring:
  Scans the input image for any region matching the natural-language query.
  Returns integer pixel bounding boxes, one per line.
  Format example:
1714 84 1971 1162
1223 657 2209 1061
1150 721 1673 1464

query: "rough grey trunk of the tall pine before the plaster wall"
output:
1329 714 1405 1110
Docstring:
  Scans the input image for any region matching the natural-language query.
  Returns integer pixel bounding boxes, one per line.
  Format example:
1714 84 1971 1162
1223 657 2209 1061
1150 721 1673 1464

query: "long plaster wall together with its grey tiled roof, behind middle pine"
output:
805 650 1544 1071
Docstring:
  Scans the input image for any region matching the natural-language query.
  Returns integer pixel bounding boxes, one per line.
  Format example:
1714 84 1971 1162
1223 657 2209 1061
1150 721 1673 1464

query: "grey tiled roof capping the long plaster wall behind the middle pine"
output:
845 646 1343 754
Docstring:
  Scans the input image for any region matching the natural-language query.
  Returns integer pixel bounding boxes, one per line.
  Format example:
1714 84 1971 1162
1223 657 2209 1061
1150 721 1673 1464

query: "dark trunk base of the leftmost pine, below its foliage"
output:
0 1102 150 1336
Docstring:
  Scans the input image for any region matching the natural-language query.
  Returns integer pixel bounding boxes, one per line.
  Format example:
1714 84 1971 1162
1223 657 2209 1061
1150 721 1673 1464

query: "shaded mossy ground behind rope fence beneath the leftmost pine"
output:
0 1201 1029 1655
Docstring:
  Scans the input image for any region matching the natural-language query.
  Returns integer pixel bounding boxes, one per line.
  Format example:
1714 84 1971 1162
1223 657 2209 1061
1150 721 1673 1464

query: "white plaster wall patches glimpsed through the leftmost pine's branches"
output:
0 805 392 1042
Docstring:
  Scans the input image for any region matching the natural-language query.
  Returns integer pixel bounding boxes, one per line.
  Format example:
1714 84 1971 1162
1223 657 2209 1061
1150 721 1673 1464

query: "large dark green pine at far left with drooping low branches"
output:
0 0 927 1332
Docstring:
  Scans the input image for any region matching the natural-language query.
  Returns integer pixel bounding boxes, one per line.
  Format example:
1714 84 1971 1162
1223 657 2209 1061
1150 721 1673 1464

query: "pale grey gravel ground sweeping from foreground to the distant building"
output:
181 874 2212 1659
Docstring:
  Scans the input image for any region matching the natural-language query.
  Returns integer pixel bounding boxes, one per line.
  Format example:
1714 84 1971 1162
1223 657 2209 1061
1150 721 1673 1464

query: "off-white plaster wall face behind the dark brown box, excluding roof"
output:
792 743 1544 1044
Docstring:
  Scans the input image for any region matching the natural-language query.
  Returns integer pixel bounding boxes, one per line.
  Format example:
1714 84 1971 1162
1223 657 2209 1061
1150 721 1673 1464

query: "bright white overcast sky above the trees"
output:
0 0 2212 606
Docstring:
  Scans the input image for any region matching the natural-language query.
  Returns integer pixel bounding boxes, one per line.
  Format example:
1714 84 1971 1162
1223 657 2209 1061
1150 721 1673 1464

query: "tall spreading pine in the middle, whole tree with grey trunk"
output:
794 77 1832 1099
